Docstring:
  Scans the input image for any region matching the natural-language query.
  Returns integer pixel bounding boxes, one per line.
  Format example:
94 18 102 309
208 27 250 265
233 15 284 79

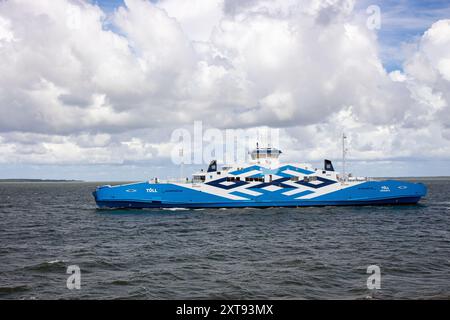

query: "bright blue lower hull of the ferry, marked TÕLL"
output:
93 180 427 209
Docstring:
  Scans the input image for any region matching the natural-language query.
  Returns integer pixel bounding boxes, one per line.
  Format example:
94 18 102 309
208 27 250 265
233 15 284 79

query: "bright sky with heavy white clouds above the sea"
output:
0 0 450 181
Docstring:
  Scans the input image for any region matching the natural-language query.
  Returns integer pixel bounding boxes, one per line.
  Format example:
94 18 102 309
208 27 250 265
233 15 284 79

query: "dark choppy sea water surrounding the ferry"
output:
0 180 450 299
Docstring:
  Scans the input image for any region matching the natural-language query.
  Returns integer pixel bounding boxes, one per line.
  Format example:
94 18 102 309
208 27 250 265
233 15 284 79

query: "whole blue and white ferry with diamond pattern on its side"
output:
93 148 427 208
